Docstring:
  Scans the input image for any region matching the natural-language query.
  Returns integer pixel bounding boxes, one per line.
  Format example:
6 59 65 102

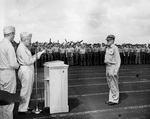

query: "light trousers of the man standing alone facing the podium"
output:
106 65 119 103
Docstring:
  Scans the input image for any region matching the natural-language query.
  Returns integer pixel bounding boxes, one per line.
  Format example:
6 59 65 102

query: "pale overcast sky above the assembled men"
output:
0 0 150 44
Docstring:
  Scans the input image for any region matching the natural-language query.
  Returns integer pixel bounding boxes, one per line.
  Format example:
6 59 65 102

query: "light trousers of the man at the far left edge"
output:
0 69 16 119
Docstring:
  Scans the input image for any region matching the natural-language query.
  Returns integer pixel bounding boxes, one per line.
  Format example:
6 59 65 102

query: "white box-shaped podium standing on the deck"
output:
44 61 69 114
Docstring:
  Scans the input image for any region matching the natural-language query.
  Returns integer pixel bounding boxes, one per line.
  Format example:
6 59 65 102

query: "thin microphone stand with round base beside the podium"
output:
32 47 42 114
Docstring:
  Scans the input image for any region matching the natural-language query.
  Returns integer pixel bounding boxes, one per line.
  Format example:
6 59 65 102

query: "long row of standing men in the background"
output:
28 43 150 67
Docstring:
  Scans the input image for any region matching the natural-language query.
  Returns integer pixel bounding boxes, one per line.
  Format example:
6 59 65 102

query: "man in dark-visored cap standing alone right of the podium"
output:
104 35 121 105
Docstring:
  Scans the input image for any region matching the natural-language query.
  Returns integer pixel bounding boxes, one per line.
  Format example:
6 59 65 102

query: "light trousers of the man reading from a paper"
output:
18 65 34 112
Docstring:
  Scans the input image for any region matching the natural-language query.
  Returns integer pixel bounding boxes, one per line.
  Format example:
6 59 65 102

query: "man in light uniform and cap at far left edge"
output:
0 26 19 119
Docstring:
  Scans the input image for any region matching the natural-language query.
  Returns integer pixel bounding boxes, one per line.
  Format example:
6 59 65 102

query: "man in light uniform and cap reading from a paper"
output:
17 32 45 114
